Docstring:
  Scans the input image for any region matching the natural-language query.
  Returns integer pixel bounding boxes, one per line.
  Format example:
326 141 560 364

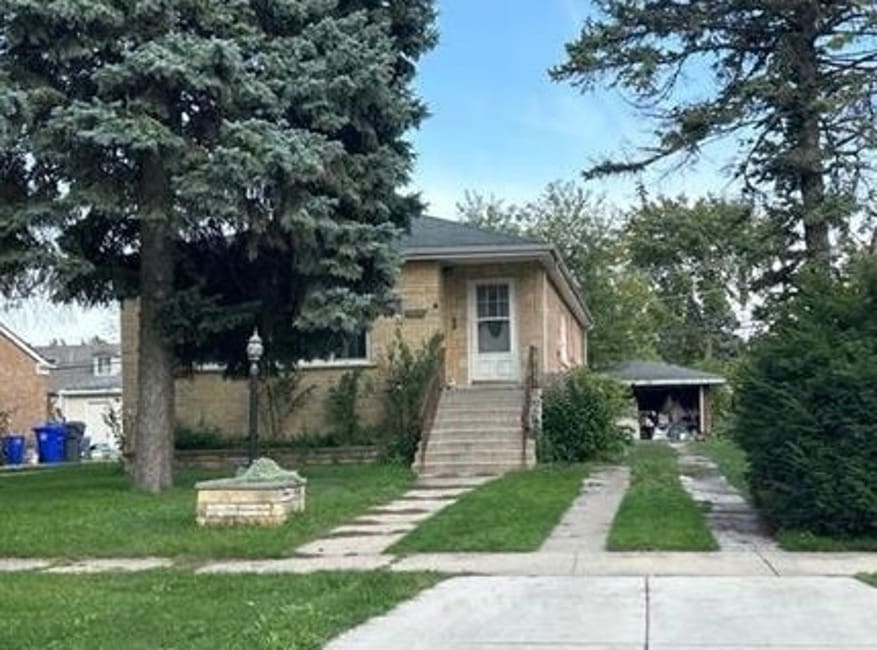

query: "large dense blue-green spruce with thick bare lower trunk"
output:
0 0 434 490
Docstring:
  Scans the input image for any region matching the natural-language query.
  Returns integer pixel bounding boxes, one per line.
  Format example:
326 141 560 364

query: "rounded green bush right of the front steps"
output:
537 368 629 463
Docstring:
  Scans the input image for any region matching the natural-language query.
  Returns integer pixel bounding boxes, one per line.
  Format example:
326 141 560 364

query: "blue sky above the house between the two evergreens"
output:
412 0 727 218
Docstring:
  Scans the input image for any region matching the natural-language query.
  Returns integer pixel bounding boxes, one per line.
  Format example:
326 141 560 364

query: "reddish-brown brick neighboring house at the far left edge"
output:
0 323 51 438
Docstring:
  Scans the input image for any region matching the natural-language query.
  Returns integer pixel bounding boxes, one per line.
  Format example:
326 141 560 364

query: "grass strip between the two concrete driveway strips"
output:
606 442 718 551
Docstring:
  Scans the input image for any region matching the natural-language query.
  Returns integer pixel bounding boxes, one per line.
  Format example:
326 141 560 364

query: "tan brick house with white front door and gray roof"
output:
121 217 590 470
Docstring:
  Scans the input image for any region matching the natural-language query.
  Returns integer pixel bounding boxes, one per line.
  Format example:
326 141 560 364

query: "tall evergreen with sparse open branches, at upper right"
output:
553 0 877 280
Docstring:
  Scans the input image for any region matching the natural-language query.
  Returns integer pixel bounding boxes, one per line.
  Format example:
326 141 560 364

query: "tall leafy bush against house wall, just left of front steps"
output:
384 330 443 463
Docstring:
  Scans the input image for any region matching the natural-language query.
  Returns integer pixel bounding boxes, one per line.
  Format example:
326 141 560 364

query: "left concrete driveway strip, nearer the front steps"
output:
540 467 630 553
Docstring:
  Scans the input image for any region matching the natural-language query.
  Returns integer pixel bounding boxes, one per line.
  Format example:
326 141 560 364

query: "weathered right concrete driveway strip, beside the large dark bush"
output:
678 445 779 551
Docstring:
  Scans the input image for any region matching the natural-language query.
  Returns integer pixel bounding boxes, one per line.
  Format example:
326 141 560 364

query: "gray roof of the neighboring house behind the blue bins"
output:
37 341 122 393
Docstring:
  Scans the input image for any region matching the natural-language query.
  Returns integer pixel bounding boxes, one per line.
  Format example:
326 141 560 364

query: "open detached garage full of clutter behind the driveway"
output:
609 361 727 439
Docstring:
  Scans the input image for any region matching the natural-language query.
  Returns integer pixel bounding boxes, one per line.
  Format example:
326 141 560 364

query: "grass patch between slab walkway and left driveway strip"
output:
389 465 585 553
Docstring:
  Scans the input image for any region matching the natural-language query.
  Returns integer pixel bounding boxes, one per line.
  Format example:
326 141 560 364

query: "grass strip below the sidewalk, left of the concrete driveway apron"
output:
0 571 439 650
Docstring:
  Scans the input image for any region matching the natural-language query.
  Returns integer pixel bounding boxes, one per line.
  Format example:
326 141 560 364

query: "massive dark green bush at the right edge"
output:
735 264 877 535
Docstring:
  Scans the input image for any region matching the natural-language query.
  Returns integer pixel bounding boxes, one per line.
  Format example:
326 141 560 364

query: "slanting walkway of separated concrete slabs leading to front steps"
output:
295 476 495 557
